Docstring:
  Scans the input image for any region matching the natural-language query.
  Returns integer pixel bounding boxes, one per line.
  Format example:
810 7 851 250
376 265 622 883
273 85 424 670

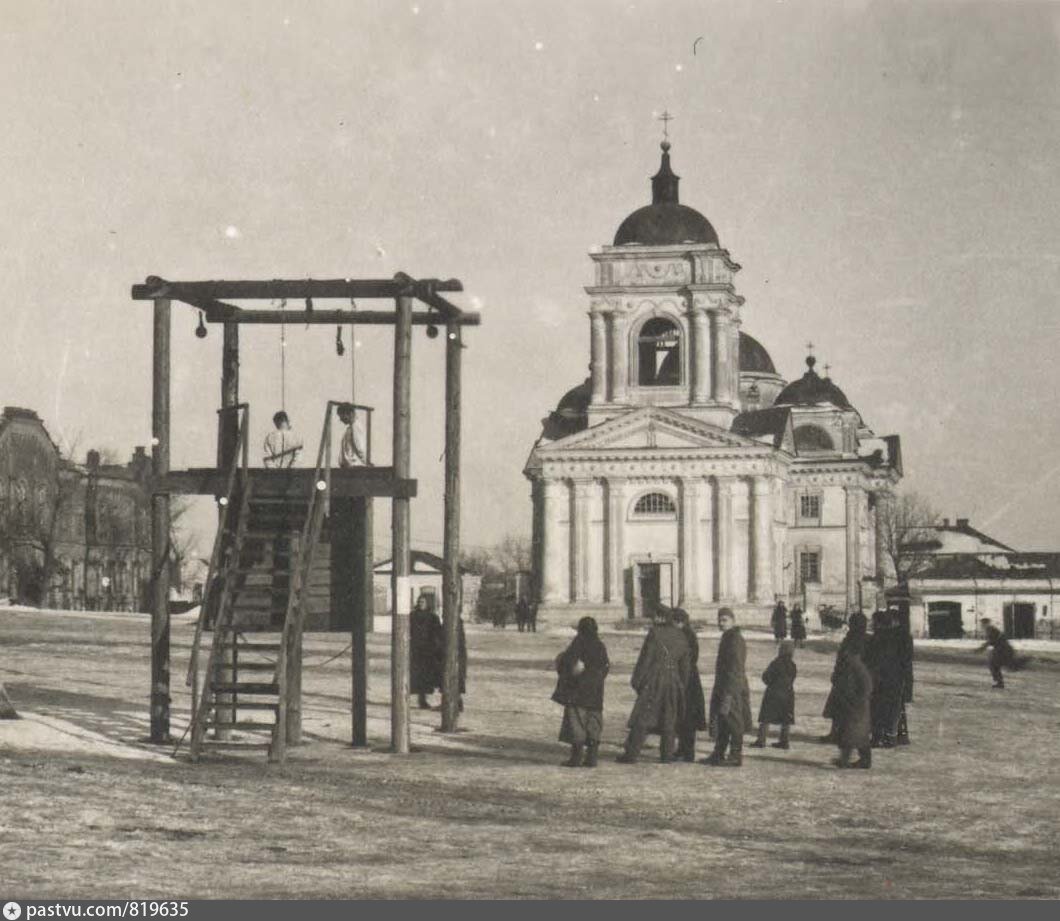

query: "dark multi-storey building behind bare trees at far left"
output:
0 406 151 610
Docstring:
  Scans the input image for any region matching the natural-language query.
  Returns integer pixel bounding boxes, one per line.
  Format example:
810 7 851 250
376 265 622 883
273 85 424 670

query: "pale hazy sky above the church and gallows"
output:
0 0 1060 550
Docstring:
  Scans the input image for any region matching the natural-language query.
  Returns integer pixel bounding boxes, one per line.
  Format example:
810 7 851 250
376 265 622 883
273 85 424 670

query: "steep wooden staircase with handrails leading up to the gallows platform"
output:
180 404 331 761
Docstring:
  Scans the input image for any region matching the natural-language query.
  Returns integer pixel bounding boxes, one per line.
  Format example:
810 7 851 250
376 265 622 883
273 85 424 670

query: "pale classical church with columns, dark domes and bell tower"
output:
525 141 902 623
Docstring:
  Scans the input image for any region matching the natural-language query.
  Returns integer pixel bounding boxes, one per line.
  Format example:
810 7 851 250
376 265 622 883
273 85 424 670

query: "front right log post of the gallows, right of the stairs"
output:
390 297 412 755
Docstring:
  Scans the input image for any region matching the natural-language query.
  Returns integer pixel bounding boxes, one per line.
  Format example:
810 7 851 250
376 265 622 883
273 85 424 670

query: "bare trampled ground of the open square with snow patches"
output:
0 612 1060 899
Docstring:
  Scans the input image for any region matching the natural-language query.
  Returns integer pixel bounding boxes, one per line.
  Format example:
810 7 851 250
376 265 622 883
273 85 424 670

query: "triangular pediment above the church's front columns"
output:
538 406 760 455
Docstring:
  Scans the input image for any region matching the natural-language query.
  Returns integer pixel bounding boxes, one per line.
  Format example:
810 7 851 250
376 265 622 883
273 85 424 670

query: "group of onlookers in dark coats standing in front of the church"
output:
552 603 932 769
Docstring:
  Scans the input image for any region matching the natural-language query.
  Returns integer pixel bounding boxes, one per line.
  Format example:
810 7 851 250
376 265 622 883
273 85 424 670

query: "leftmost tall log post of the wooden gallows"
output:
151 298 171 743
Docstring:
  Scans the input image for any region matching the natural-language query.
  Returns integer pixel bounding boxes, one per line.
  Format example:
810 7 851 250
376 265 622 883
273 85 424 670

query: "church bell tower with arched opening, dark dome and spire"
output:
585 140 743 429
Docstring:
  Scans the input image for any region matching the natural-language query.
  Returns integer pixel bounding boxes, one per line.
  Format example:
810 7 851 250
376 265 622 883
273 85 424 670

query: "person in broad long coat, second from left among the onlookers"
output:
618 608 691 764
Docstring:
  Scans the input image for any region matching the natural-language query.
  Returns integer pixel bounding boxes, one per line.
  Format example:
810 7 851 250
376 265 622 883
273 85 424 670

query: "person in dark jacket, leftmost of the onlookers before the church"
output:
552 617 611 767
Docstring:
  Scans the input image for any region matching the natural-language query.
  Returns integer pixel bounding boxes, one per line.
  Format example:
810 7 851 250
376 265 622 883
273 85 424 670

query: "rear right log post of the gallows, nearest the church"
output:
442 321 463 732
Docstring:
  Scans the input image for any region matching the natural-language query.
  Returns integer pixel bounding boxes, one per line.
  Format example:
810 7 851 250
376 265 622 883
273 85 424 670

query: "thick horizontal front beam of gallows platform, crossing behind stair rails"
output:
155 467 417 499
